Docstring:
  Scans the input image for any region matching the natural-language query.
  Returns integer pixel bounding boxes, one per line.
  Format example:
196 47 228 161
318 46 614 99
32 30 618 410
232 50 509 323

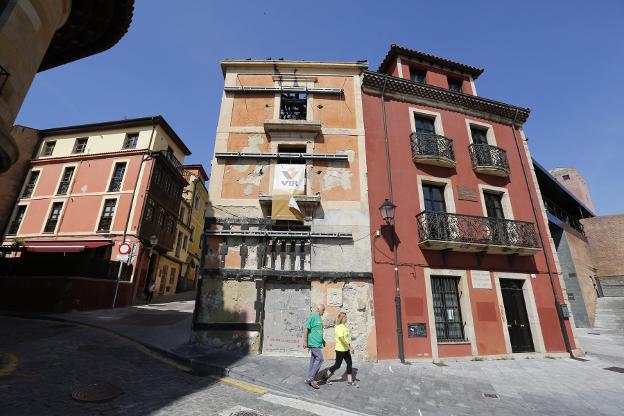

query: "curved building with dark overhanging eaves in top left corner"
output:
0 0 134 172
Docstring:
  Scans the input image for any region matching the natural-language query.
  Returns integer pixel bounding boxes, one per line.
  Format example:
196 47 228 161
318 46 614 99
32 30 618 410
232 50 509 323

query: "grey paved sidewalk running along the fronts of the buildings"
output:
17 299 624 415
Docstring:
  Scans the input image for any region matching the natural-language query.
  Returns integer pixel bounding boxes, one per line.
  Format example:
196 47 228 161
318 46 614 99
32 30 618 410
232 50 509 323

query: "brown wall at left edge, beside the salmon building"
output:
0 126 39 240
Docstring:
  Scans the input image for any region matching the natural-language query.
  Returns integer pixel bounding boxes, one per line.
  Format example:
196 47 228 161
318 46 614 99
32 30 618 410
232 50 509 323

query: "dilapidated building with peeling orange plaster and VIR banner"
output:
194 60 377 359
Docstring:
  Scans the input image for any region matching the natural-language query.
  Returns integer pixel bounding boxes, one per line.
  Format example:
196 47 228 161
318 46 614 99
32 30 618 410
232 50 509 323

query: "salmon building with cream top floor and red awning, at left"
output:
0 116 190 310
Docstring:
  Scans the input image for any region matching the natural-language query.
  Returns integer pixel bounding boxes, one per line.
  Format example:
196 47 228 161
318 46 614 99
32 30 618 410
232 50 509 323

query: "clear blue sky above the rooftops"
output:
17 0 624 215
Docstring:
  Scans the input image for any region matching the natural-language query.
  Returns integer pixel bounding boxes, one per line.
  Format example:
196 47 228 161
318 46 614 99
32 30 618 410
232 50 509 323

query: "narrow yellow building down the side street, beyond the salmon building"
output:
154 165 208 296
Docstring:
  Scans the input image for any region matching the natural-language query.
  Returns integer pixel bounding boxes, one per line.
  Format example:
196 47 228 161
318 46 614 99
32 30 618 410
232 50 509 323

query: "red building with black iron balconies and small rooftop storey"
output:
362 45 577 360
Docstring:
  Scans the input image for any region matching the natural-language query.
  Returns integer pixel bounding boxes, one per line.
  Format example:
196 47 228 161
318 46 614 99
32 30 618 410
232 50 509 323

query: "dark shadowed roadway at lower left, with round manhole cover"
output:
0 317 348 416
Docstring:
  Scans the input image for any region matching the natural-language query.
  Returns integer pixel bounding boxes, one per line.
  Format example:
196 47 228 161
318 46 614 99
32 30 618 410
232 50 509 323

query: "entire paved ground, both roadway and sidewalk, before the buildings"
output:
0 300 624 416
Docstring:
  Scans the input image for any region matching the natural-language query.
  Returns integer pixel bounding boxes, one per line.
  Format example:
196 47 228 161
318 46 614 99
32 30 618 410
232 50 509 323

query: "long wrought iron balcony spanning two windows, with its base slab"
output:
416 211 541 256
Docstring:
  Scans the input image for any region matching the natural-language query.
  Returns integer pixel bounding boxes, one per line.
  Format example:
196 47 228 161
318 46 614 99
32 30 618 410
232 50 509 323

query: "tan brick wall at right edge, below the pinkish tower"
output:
582 215 624 279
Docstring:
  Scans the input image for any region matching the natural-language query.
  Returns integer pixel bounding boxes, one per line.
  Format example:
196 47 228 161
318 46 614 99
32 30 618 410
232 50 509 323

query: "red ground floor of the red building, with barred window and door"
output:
375 267 575 361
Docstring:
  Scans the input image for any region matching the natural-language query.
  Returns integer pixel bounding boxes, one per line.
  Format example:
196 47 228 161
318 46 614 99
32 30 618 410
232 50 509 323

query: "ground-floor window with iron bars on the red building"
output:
431 276 464 342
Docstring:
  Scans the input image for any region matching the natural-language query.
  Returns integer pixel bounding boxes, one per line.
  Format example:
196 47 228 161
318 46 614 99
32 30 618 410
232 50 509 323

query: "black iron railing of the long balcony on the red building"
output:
416 211 540 248
